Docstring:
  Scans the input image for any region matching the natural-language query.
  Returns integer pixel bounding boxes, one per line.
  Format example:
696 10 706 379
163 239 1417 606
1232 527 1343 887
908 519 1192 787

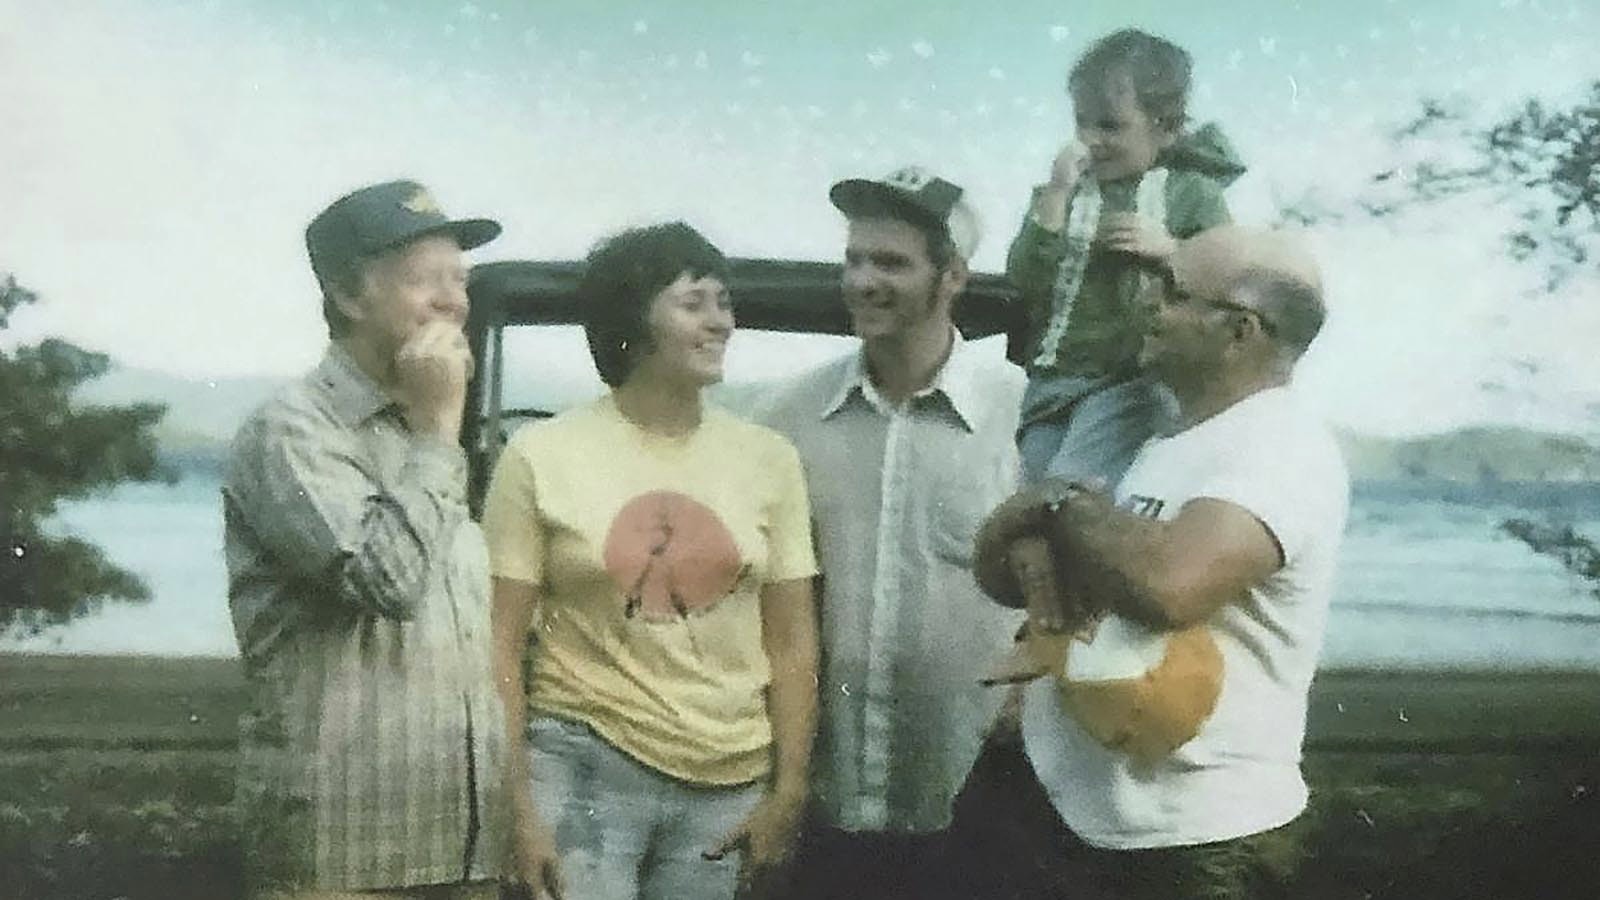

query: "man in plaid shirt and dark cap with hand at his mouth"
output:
222 181 506 900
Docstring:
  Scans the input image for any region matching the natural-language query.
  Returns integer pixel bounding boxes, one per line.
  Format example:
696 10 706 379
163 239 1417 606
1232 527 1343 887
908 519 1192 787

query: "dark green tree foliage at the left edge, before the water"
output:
0 275 166 634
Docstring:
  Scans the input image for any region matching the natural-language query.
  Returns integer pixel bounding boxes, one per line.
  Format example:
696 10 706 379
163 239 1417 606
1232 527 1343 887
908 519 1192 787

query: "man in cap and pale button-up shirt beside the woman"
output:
765 168 1022 898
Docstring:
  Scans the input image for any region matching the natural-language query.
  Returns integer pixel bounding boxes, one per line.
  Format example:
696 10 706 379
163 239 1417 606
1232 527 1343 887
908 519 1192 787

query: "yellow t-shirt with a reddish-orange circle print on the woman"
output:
483 396 816 785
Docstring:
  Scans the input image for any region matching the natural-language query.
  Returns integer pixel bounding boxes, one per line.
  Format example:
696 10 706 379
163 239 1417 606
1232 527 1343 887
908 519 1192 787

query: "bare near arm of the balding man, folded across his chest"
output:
1043 490 1283 629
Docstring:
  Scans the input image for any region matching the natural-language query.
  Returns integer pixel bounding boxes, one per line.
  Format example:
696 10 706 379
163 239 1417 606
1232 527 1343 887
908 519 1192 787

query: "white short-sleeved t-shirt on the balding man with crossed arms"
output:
1022 388 1349 850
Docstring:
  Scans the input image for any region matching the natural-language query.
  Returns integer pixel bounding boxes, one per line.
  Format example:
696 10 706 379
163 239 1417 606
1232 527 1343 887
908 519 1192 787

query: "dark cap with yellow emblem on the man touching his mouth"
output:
306 181 501 282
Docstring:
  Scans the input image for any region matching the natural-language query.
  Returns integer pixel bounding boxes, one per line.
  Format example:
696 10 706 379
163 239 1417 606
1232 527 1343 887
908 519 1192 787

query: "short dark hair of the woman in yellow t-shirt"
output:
578 223 728 388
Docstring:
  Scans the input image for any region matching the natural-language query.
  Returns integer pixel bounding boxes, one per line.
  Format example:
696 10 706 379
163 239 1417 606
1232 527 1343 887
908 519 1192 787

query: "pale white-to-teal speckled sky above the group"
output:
0 0 1600 436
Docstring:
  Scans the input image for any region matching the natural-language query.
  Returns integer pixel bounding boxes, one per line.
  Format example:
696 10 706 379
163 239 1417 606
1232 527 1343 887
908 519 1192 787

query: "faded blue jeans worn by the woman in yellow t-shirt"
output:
528 717 763 900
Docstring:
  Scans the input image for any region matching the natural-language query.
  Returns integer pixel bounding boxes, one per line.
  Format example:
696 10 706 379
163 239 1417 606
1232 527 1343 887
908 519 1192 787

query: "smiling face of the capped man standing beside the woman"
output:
843 218 965 341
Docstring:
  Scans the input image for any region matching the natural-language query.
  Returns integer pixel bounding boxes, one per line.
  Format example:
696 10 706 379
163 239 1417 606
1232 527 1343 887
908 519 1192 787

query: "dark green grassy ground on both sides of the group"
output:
0 657 1600 900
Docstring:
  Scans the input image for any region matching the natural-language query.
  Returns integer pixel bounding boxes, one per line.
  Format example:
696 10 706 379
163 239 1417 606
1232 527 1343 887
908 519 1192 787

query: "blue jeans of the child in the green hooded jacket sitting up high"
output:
1016 375 1178 488
